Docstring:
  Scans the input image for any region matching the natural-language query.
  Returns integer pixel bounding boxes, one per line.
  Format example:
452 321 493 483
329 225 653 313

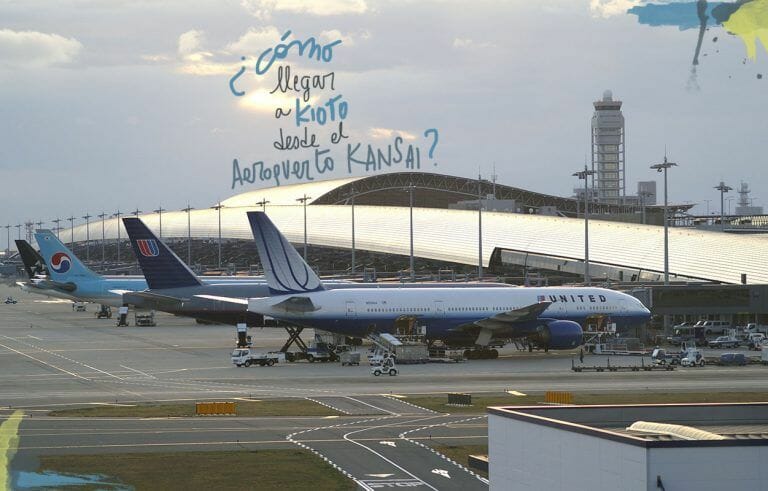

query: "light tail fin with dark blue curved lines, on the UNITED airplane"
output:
248 211 324 295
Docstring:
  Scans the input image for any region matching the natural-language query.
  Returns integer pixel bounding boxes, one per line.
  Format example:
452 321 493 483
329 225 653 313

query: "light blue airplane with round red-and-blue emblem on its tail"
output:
28 230 265 307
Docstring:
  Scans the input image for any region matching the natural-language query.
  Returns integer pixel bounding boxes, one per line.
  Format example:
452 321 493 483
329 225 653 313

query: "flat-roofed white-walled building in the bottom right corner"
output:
488 403 768 491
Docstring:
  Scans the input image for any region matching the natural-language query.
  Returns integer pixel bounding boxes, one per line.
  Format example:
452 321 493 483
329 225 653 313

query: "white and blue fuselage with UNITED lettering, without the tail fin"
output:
248 287 650 339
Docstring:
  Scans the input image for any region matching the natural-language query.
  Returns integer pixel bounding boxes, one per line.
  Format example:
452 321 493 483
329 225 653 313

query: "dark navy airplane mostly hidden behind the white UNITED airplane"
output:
123 217 506 326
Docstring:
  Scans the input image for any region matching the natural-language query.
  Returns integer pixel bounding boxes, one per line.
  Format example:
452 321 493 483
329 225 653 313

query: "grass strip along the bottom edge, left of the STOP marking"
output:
39 449 356 491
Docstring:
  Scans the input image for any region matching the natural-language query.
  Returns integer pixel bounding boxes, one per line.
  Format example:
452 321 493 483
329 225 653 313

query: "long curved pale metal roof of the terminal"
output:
61 172 768 283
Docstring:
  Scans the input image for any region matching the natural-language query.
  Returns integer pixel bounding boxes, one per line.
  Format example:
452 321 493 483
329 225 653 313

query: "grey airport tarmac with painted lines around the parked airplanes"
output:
0 286 768 489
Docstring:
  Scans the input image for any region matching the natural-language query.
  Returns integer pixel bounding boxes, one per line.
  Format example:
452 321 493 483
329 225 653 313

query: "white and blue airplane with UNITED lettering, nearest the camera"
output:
201 212 650 350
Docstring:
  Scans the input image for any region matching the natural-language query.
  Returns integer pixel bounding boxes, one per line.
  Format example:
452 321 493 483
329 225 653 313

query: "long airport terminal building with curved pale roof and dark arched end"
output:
54 172 768 284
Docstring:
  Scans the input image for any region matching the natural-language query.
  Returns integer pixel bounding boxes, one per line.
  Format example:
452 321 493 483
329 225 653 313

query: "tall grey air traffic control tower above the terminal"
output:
592 90 626 204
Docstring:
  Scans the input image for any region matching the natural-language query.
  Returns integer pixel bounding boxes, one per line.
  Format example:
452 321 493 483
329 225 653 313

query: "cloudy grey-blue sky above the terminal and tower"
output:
0 0 768 239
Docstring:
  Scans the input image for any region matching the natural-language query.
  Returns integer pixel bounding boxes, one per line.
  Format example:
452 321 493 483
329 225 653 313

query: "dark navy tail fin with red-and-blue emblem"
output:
123 217 201 290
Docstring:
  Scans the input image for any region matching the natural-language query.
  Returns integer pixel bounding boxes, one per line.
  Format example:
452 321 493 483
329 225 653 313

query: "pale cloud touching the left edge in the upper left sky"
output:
0 29 83 68
